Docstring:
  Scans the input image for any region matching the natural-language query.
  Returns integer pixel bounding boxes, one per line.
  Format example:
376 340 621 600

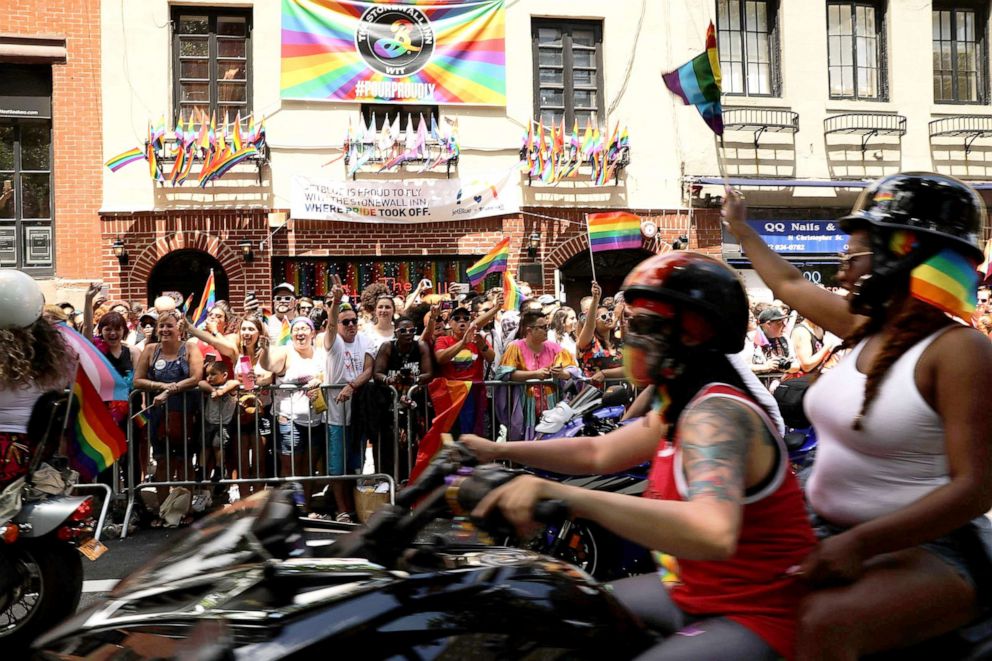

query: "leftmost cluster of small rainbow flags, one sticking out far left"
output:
104 111 265 187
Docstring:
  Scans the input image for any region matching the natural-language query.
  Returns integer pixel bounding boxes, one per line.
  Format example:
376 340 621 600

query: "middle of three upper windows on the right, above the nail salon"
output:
827 2 885 100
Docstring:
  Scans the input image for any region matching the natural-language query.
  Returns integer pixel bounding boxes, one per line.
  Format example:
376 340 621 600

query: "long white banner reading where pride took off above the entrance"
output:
291 168 521 223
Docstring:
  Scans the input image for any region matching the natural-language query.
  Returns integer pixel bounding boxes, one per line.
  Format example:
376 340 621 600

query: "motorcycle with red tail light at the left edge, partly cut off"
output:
0 394 106 652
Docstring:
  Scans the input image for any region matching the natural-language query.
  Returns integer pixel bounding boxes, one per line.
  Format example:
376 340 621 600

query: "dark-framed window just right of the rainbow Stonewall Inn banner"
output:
531 19 603 129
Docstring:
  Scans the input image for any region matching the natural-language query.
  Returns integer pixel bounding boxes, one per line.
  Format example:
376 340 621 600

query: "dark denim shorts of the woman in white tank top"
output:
810 513 992 606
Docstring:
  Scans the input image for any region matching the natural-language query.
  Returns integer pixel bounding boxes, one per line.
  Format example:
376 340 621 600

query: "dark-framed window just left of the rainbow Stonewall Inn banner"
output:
172 7 251 120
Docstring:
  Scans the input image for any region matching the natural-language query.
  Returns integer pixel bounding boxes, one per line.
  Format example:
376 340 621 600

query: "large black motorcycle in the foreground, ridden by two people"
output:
35 445 992 661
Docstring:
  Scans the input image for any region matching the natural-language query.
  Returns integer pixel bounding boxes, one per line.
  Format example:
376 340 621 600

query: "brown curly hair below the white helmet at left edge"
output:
0 318 77 390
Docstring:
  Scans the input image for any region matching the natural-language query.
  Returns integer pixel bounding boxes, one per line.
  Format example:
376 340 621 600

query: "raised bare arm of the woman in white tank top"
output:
723 191 865 337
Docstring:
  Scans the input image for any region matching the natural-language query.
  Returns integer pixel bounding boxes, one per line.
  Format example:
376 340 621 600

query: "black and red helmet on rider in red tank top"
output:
623 251 748 353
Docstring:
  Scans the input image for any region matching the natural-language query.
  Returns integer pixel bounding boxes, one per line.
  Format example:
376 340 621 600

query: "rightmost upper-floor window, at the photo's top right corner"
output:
933 5 986 103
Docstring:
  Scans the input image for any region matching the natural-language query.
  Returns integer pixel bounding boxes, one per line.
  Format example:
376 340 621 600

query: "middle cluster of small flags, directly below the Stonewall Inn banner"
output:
336 113 461 177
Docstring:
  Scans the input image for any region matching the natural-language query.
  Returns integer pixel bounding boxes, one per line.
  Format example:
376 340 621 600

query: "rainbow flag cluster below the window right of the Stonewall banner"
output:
520 118 630 186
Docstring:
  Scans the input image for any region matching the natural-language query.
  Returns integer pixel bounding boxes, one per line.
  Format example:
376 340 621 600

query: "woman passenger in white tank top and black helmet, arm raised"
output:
724 173 992 659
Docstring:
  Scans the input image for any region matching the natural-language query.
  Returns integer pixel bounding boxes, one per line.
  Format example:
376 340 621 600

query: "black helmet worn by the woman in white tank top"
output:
839 172 986 315
